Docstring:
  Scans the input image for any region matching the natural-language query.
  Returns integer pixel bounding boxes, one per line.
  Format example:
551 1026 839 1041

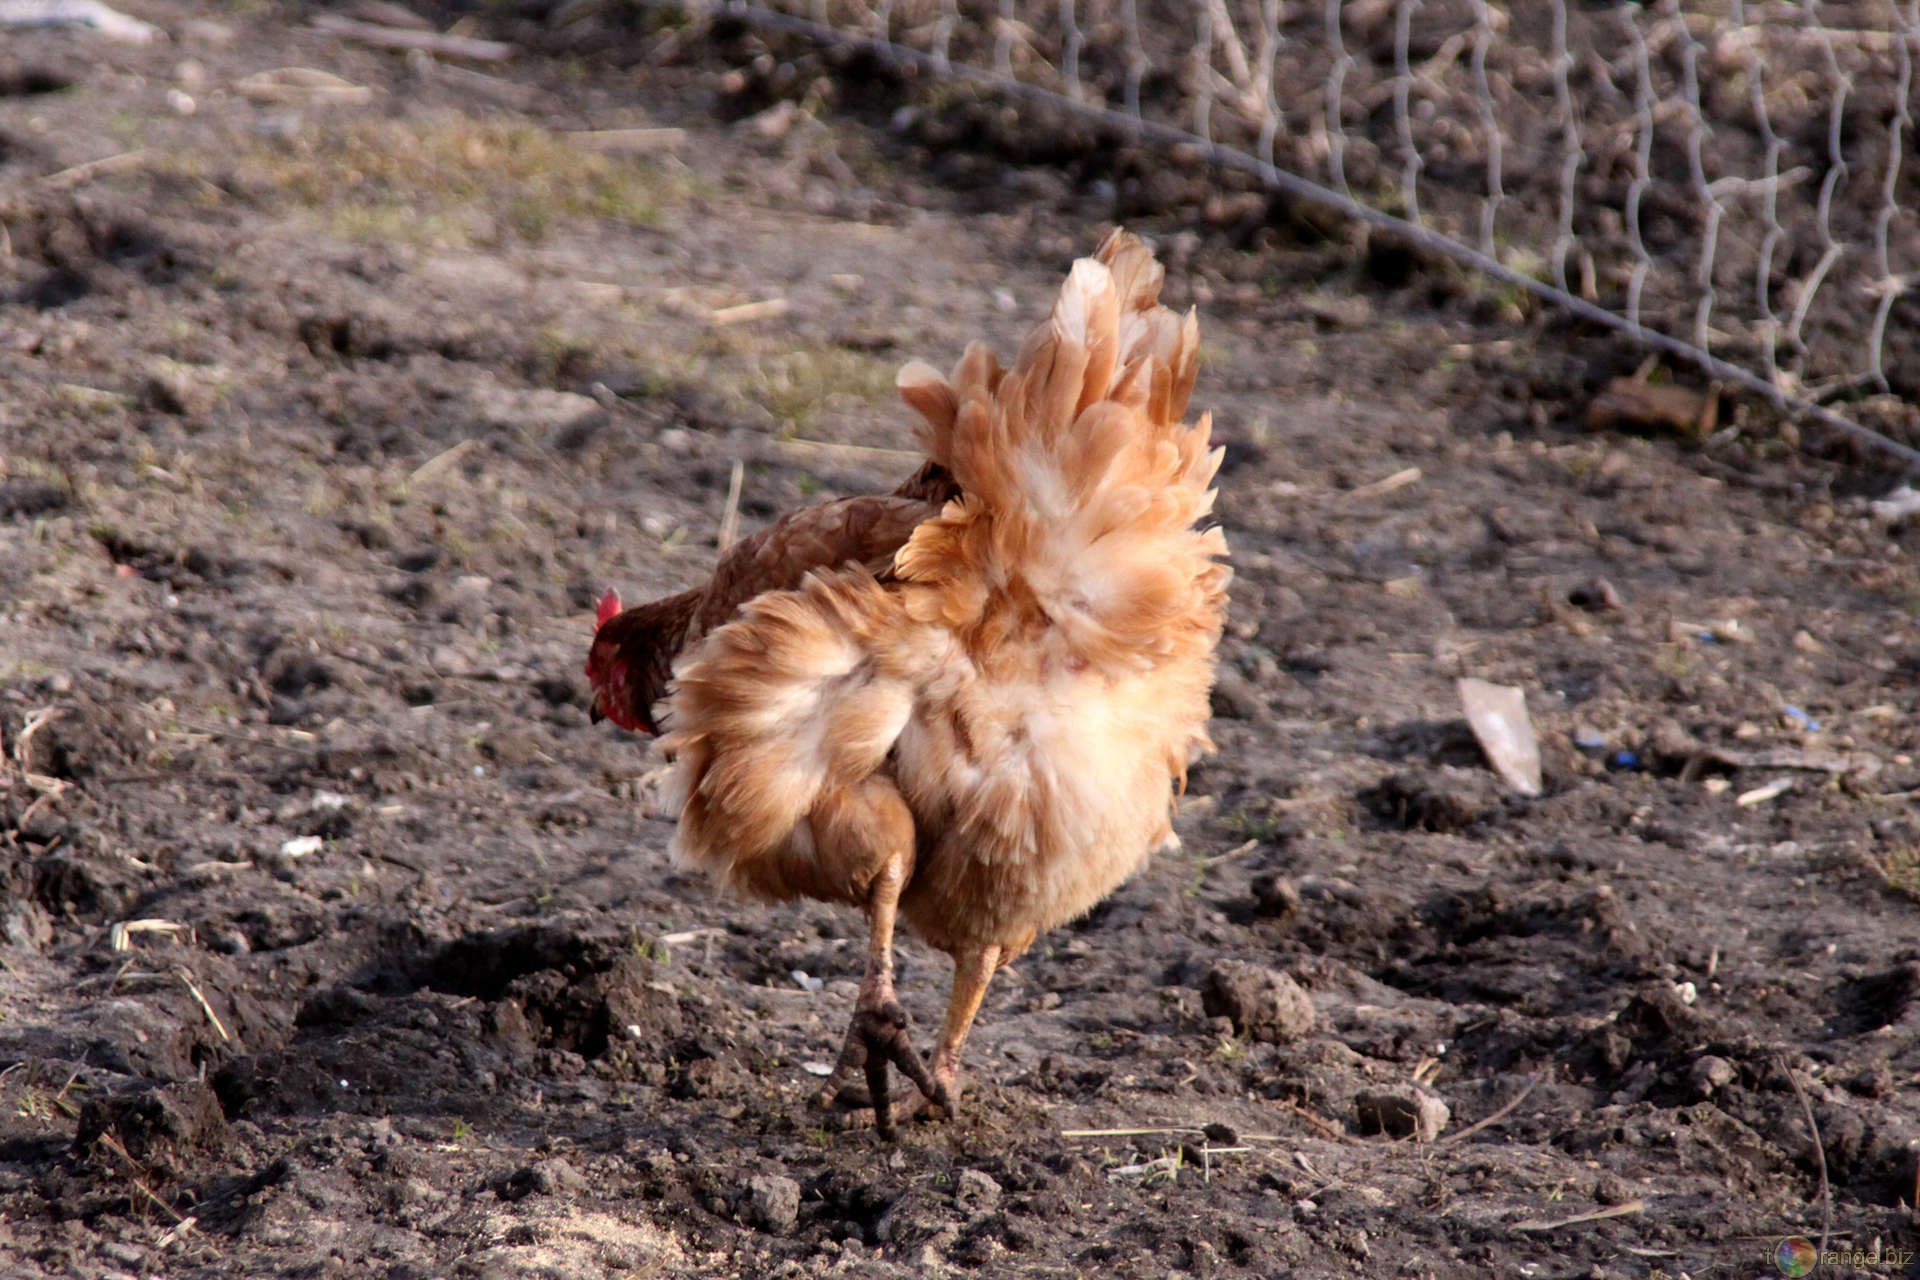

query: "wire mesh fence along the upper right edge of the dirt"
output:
660 0 1920 472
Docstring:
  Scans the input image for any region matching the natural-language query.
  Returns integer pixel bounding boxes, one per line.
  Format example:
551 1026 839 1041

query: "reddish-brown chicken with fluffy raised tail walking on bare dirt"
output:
588 230 1229 1138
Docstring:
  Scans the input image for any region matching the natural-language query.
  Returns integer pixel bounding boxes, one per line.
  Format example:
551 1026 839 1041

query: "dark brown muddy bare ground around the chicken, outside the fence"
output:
0 0 1920 1280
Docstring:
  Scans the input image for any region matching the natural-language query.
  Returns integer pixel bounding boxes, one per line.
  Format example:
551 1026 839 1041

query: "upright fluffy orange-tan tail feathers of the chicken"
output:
895 232 1227 668
